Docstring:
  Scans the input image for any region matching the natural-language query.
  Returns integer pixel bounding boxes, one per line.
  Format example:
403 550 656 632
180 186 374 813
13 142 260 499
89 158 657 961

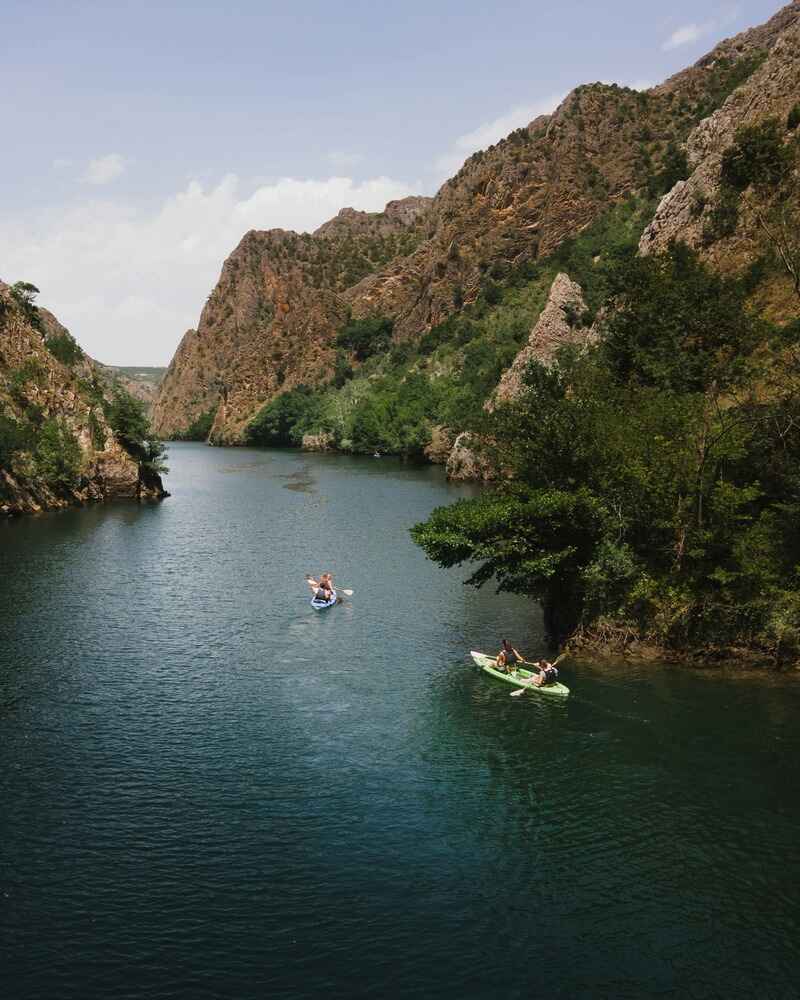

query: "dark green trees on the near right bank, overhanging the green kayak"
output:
413 240 800 659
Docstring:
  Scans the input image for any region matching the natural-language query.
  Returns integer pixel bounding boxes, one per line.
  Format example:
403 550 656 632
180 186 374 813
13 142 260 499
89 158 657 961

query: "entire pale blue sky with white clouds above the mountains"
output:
0 0 780 364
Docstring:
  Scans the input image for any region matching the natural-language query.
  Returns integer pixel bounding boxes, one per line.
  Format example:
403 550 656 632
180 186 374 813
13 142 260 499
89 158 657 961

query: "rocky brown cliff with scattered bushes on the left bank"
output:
0 283 166 514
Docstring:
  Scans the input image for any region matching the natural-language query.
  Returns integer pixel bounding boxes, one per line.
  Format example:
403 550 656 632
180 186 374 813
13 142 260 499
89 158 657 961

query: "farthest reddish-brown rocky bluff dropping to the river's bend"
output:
153 198 430 443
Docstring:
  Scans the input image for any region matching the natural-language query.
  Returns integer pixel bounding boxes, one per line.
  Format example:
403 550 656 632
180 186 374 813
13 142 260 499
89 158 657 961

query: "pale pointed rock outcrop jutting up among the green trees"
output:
494 274 597 408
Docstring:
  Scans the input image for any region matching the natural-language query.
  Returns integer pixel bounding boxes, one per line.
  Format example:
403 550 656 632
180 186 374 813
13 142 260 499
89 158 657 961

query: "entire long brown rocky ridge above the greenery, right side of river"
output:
154 3 800 443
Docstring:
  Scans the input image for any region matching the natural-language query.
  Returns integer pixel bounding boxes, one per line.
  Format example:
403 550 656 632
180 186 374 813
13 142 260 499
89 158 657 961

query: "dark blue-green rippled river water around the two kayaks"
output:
0 445 800 1000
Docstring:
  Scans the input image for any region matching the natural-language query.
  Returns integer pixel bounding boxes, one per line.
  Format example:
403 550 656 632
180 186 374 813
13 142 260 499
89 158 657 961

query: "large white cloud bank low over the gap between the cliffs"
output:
0 175 420 364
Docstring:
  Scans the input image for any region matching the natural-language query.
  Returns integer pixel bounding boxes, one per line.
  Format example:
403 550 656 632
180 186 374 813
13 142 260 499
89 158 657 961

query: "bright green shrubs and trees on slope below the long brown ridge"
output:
247 198 653 458
